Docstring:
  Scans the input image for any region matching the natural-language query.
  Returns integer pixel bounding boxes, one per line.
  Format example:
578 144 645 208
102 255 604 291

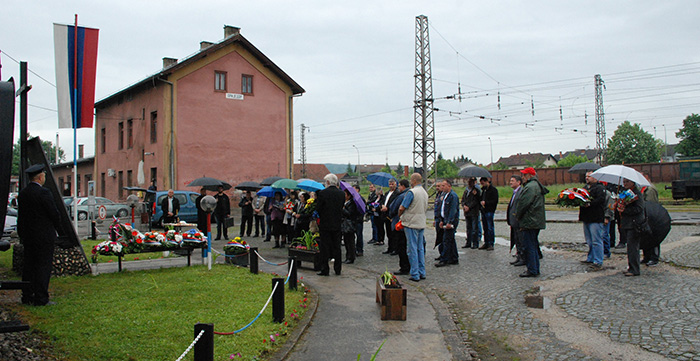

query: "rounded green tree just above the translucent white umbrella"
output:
607 121 663 164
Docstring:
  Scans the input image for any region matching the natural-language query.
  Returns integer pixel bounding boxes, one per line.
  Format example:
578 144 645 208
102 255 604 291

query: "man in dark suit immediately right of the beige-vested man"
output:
435 179 459 267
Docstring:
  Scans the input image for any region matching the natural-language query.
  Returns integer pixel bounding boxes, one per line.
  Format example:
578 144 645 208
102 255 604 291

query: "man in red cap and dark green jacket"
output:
515 167 549 277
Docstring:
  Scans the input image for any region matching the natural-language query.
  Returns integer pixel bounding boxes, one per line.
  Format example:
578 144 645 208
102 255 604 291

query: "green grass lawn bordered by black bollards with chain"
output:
3 262 308 360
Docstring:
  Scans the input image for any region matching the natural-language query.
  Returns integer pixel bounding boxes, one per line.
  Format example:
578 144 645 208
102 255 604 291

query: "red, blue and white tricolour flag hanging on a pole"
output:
53 24 99 128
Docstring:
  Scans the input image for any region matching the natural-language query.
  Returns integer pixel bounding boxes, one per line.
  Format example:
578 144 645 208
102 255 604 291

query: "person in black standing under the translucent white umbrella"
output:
617 178 644 276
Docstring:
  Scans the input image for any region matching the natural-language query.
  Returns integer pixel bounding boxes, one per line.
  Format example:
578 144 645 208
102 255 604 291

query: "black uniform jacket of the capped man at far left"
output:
17 182 60 248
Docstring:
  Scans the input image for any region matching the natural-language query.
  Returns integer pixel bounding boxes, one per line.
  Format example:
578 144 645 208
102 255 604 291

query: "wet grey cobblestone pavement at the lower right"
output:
356 218 700 360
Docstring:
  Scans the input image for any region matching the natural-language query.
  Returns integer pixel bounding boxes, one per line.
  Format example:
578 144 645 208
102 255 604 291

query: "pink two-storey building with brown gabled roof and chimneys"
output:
95 26 304 200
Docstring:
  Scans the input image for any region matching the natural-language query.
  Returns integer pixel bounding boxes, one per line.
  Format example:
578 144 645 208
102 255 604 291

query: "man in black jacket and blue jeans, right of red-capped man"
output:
578 172 606 272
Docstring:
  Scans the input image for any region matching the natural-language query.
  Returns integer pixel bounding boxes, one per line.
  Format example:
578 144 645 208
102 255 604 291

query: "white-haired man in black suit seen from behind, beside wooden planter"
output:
316 173 345 276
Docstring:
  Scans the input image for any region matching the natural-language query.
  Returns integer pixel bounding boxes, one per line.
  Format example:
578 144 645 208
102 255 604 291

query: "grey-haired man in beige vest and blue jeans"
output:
399 173 428 282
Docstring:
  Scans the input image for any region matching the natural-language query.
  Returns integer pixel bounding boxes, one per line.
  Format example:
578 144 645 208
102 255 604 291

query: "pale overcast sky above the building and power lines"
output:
0 0 700 165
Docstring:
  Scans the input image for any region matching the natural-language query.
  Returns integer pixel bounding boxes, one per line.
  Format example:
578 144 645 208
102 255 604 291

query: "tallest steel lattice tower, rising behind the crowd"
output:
413 15 437 190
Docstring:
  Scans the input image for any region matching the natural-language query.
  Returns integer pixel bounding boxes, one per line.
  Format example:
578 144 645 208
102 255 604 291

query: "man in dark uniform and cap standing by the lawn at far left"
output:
17 164 60 306
